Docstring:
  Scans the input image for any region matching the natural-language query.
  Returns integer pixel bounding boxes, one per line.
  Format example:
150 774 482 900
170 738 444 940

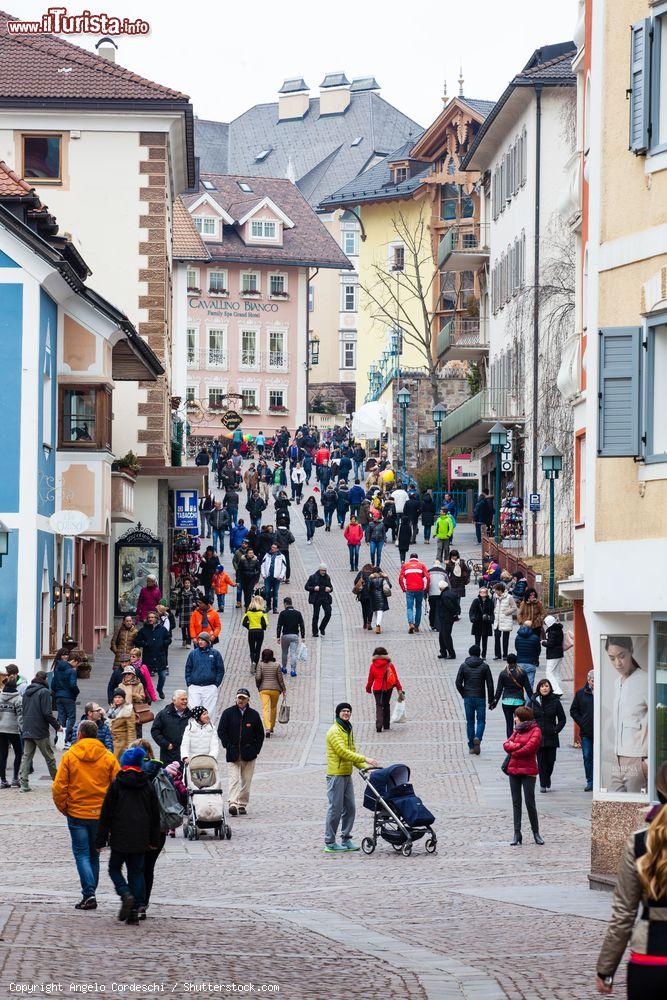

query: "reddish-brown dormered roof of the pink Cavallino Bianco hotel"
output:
174 174 352 270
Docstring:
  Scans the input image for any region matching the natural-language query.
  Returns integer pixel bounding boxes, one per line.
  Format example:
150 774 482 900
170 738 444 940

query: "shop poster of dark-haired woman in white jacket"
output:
599 635 648 795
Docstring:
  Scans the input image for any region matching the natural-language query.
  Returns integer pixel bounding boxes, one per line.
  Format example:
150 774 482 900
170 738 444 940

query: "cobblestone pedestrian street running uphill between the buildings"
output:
0 496 610 1000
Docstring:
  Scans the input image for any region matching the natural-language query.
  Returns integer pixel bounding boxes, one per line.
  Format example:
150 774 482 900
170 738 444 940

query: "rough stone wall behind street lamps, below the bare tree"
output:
385 371 470 474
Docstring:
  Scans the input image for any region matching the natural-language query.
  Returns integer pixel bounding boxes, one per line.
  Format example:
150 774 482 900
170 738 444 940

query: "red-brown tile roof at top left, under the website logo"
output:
0 11 188 101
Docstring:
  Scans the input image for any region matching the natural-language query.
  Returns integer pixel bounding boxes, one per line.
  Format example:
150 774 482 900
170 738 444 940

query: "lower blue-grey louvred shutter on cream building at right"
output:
597 326 642 457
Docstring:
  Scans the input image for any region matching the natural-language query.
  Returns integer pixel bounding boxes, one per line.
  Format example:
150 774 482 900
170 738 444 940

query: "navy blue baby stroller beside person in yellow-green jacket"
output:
359 764 438 858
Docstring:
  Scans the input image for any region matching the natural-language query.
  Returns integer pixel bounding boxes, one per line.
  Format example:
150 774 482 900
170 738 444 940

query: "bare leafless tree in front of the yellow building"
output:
361 207 442 405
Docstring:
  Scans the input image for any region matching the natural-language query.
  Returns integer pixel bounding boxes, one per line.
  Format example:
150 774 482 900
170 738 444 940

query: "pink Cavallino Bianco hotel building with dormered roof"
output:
174 174 351 438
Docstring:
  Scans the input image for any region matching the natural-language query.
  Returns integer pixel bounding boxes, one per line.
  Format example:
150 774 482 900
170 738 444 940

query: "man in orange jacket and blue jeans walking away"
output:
51 720 120 910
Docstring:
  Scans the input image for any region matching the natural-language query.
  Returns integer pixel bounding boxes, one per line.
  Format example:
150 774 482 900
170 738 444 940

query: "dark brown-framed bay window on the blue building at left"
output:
58 385 112 451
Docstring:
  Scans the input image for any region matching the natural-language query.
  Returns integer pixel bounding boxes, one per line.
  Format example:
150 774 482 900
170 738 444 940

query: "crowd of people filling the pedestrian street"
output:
0 428 667 992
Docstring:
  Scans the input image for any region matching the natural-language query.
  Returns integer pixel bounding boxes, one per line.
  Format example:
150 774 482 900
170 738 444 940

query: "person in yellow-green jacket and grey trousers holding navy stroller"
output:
324 701 379 854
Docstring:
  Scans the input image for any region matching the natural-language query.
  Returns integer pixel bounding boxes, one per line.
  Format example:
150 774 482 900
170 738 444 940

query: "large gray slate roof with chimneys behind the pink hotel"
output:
195 90 422 206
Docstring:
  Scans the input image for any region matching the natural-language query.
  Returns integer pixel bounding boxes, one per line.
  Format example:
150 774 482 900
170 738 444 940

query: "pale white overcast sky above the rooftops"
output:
15 0 578 125
